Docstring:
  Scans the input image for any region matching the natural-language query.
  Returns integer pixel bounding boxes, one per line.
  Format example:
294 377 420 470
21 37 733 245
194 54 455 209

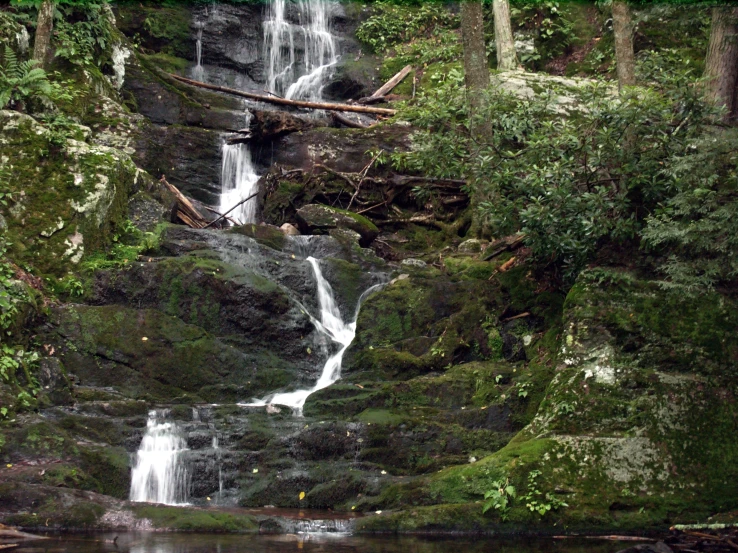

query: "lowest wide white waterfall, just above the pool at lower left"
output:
130 411 189 505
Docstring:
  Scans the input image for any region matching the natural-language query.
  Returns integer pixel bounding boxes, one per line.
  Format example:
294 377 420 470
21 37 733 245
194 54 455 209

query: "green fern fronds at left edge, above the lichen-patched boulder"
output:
0 46 74 109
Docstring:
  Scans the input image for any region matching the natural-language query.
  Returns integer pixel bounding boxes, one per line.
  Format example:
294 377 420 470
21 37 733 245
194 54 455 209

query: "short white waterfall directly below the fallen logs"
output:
219 144 259 224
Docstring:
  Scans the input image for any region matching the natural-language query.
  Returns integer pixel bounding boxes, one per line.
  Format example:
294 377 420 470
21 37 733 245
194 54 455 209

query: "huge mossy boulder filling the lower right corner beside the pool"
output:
360 269 738 530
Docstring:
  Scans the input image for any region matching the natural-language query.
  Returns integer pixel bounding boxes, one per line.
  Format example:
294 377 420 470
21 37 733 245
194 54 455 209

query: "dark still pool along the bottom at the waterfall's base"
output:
8 533 632 553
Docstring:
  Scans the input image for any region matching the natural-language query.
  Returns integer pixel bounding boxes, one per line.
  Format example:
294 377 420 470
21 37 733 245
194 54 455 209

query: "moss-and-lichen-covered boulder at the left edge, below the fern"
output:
0 111 143 275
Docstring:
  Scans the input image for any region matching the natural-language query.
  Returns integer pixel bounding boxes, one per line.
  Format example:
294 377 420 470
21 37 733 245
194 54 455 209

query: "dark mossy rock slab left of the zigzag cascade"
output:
48 306 300 403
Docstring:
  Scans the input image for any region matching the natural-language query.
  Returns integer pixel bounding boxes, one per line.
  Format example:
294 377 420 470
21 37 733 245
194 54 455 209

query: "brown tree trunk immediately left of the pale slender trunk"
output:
461 0 489 95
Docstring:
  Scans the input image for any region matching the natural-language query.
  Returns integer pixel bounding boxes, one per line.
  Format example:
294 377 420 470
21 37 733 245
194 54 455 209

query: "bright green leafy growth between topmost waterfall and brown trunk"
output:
356 1 458 53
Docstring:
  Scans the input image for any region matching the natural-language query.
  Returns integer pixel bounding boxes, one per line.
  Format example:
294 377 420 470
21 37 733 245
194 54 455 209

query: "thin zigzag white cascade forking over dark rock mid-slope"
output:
242 257 382 416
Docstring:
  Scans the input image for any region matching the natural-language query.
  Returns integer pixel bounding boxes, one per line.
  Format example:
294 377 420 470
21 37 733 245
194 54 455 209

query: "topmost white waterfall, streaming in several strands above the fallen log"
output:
264 0 339 101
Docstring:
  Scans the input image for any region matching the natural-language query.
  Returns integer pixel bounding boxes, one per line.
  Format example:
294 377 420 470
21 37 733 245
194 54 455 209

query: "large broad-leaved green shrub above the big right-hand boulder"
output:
393 66 712 283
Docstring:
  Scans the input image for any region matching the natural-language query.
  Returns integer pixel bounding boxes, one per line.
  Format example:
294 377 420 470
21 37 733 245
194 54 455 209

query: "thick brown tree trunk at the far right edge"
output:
705 8 738 121
